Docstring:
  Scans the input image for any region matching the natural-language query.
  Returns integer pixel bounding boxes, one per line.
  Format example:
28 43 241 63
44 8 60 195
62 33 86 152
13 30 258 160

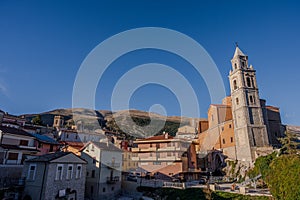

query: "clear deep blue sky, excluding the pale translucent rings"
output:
0 0 300 125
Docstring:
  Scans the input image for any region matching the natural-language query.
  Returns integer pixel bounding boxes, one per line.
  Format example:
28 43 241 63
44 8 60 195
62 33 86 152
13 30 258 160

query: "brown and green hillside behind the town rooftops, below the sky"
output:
19 108 203 138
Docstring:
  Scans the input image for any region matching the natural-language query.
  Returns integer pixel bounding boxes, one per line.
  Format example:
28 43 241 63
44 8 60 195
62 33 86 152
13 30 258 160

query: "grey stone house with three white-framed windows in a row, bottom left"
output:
22 152 86 200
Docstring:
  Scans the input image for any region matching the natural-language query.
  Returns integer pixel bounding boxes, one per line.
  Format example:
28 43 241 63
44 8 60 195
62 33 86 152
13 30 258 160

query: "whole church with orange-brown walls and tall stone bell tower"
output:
198 46 284 166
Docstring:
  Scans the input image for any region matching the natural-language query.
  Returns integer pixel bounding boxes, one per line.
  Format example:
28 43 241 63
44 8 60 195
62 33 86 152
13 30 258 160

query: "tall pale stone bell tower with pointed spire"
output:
229 46 269 163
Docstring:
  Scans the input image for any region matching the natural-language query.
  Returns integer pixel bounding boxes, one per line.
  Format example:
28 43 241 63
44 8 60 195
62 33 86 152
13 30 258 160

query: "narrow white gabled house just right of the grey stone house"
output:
81 141 122 199
